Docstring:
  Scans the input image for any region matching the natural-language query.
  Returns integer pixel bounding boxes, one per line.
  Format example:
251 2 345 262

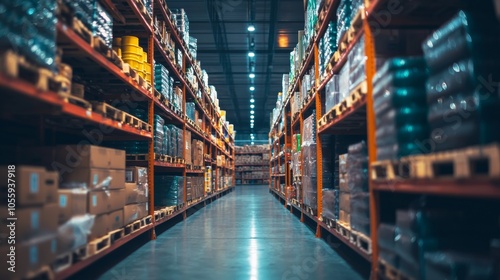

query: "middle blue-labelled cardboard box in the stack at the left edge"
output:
0 203 59 242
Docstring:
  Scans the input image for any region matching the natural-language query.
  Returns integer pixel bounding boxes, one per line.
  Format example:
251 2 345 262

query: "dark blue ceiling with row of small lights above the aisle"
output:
167 0 304 144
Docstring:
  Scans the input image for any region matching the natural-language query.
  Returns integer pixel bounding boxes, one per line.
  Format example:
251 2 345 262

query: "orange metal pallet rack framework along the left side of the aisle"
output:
0 0 235 279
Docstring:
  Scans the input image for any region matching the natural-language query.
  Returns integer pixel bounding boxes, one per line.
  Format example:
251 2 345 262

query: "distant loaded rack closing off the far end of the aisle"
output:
235 150 269 185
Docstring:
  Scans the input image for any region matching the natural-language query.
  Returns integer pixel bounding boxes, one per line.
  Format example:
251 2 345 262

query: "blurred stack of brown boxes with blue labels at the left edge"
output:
0 165 59 279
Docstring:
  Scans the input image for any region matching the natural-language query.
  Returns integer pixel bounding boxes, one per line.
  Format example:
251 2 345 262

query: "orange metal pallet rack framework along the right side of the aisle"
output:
269 0 500 279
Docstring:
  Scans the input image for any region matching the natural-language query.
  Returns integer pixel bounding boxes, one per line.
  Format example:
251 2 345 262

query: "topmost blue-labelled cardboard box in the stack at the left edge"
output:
0 166 47 207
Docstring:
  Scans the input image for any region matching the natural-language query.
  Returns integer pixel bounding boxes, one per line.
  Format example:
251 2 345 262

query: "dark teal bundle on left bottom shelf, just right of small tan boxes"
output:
154 175 184 206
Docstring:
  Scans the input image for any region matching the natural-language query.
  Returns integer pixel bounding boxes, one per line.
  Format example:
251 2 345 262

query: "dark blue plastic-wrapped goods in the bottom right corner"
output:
425 251 495 280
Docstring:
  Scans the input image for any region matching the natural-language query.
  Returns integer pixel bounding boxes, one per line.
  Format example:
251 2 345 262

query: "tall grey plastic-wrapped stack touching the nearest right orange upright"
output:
347 142 371 236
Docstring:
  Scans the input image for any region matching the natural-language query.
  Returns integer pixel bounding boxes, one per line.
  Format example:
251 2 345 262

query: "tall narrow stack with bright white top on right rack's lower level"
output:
301 111 318 209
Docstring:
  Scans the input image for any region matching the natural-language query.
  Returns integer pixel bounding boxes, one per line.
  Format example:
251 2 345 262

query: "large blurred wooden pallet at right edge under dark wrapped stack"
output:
400 143 500 180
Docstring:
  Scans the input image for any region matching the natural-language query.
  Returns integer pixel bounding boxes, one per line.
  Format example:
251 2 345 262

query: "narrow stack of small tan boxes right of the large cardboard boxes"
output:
123 167 149 225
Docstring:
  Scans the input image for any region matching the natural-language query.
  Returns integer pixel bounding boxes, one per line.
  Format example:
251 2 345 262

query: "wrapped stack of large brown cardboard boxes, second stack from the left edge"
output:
54 145 125 241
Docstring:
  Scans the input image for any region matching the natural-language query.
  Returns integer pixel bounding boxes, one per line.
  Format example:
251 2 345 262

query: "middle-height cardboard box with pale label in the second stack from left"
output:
87 189 125 215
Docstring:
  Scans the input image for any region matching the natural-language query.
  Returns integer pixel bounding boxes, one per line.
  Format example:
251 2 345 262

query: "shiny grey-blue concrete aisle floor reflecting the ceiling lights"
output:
100 186 362 280
